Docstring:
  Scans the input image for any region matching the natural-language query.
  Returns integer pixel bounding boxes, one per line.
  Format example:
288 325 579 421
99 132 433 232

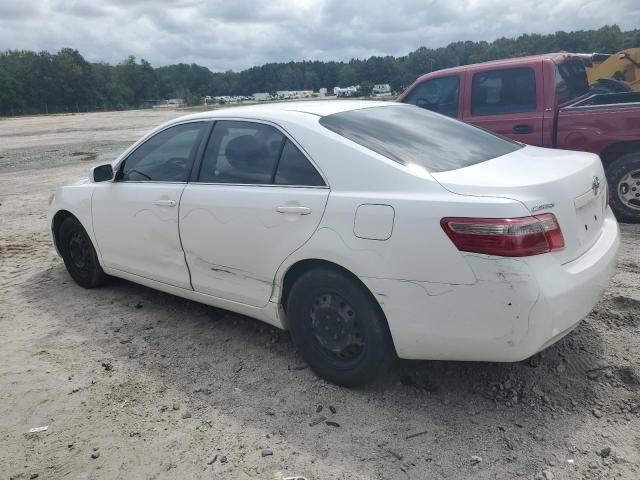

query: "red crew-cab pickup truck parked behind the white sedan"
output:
399 53 640 223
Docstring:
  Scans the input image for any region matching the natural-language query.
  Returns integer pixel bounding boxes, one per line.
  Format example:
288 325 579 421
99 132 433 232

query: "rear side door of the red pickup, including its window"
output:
462 62 544 146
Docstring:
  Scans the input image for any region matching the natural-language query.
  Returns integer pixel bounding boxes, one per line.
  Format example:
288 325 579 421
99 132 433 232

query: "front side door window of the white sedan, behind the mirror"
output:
118 122 203 182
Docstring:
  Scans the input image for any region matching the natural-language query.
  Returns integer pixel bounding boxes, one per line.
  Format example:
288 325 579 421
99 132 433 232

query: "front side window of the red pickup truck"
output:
404 75 460 117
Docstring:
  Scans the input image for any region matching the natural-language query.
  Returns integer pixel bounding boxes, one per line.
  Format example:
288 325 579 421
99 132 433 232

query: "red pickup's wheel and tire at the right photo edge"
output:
606 152 640 223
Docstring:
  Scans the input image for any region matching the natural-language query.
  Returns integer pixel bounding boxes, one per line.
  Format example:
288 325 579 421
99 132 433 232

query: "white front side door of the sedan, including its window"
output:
92 122 204 289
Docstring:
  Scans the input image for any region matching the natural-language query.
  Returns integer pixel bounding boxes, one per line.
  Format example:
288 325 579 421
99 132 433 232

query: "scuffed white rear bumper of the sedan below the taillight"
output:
362 211 620 362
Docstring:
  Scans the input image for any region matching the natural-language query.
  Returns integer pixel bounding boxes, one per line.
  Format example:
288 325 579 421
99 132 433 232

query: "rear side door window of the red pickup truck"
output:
471 68 536 115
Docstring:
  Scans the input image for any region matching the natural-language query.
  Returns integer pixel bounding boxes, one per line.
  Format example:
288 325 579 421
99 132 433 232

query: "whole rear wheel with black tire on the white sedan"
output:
286 268 395 387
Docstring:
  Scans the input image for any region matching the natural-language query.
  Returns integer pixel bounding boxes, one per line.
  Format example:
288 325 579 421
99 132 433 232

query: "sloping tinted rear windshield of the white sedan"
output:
320 105 523 172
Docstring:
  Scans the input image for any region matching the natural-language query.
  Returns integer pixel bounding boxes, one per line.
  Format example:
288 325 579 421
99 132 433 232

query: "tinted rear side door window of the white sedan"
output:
199 120 324 186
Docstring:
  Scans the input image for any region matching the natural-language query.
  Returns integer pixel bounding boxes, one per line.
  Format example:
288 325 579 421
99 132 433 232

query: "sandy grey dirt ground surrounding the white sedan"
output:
0 111 640 480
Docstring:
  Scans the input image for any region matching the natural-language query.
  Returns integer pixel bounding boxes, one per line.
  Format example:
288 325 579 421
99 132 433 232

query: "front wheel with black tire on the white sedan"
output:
58 217 107 288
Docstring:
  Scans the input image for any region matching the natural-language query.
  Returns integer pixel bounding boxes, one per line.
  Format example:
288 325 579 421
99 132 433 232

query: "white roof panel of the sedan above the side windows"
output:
174 99 399 121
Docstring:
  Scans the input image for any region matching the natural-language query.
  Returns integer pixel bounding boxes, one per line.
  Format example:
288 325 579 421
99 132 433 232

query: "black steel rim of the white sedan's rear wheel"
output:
309 292 367 363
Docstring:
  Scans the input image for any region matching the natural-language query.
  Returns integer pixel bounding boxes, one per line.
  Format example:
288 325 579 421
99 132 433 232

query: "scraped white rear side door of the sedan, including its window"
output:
180 120 329 307
